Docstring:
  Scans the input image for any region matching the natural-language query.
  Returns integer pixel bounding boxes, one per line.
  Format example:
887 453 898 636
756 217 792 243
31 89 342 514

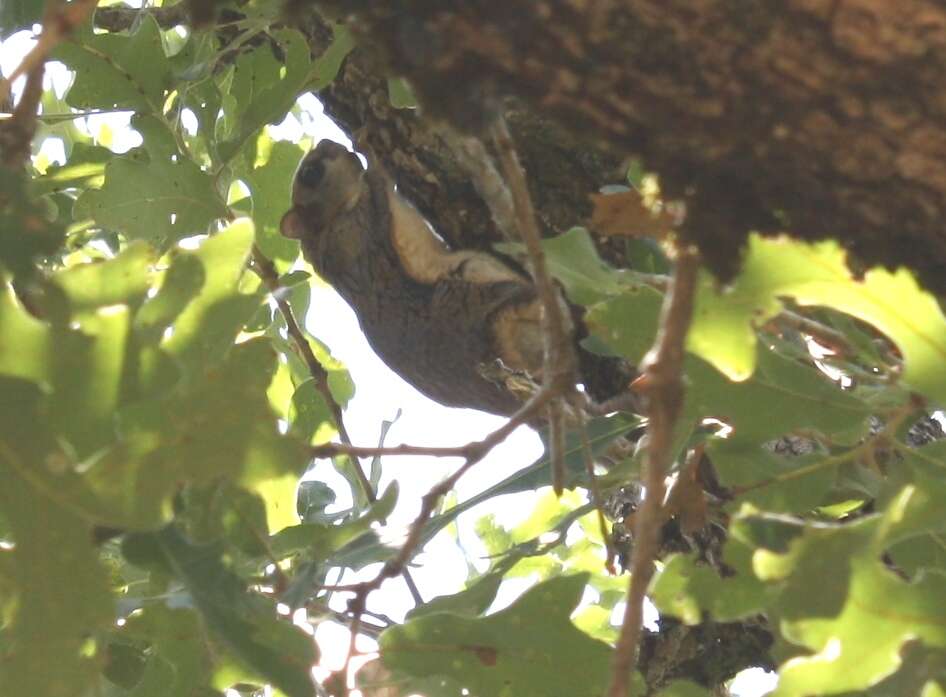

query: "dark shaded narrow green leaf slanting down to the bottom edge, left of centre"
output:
154 527 318 697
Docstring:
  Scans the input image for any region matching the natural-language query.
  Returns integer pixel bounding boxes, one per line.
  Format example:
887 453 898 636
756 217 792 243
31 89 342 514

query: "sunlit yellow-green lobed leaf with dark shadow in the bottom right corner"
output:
731 485 946 697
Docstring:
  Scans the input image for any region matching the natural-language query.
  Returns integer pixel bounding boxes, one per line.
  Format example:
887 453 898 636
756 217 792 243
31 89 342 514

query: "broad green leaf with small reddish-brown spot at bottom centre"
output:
380 574 636 697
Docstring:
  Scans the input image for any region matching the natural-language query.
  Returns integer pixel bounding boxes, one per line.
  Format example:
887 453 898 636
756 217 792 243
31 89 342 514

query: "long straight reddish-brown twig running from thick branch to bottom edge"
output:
608 248 699 697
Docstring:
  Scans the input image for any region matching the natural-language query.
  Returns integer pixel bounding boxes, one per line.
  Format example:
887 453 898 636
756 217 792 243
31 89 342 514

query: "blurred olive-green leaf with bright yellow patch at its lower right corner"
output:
103 338 307 535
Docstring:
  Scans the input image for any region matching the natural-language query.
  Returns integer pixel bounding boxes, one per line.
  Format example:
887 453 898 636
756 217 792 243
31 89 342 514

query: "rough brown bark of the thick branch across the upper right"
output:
306 0 946 293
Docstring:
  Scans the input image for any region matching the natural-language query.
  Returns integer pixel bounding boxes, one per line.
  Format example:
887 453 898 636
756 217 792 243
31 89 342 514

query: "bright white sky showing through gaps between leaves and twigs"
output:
0 24 774 697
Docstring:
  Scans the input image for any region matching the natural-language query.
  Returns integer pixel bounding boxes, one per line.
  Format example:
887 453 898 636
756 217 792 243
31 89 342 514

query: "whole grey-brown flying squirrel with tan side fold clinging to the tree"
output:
281 140 632 415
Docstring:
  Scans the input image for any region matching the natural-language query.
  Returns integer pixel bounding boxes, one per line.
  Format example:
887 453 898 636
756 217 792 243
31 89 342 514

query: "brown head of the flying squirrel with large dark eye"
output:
280 140 365 239
